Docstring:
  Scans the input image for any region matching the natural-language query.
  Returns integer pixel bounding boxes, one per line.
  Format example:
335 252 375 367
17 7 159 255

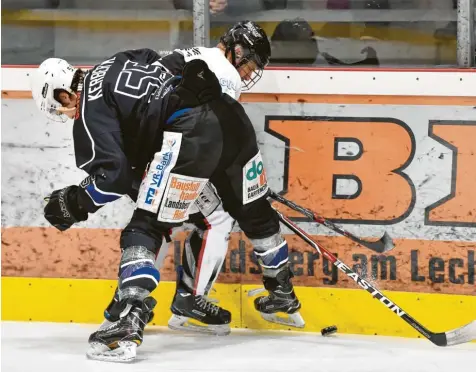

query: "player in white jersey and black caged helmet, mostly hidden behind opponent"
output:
156 22 303 335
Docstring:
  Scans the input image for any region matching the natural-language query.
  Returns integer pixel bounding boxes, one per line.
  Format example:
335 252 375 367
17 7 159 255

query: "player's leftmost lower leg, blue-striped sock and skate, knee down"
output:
87 209 169 362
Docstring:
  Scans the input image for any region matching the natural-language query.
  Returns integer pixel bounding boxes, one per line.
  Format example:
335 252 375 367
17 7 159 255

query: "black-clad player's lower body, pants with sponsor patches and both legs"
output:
91 61 300 364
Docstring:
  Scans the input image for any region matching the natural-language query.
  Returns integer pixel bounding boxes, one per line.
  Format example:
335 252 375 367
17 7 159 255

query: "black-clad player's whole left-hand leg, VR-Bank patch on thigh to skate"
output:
88 130 219 361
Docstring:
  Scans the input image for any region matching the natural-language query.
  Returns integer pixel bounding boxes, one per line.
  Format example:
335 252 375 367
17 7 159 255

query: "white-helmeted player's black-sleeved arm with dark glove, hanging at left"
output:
44 77 132 231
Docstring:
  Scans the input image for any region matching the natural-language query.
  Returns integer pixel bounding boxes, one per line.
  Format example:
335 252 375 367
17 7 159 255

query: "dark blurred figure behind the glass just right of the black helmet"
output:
270 18 379 66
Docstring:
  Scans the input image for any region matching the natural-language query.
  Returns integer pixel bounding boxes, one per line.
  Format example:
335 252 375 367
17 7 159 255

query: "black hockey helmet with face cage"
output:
220 21 271 90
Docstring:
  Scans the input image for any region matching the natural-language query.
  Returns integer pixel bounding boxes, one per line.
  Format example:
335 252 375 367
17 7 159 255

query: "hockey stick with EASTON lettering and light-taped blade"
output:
276 211 476 346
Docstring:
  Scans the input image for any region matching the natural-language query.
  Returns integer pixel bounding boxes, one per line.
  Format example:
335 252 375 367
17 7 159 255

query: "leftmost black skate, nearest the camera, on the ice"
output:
86 297 157 363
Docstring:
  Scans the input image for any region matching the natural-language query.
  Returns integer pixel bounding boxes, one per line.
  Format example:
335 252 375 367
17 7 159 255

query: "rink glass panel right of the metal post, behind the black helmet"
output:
206 0 457 68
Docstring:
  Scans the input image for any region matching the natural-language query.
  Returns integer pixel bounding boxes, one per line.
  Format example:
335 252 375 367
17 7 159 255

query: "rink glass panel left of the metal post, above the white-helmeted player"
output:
2 0 193 65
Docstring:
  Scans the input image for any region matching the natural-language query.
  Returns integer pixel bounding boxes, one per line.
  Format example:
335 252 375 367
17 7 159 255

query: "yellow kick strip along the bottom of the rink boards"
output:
2 278 476 337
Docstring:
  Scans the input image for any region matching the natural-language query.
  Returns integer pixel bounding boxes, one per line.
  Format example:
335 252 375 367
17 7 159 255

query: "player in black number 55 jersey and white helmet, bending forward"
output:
33 21 300 360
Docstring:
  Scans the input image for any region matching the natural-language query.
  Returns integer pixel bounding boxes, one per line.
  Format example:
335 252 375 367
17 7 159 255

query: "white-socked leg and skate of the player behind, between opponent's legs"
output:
169 184 234 335
